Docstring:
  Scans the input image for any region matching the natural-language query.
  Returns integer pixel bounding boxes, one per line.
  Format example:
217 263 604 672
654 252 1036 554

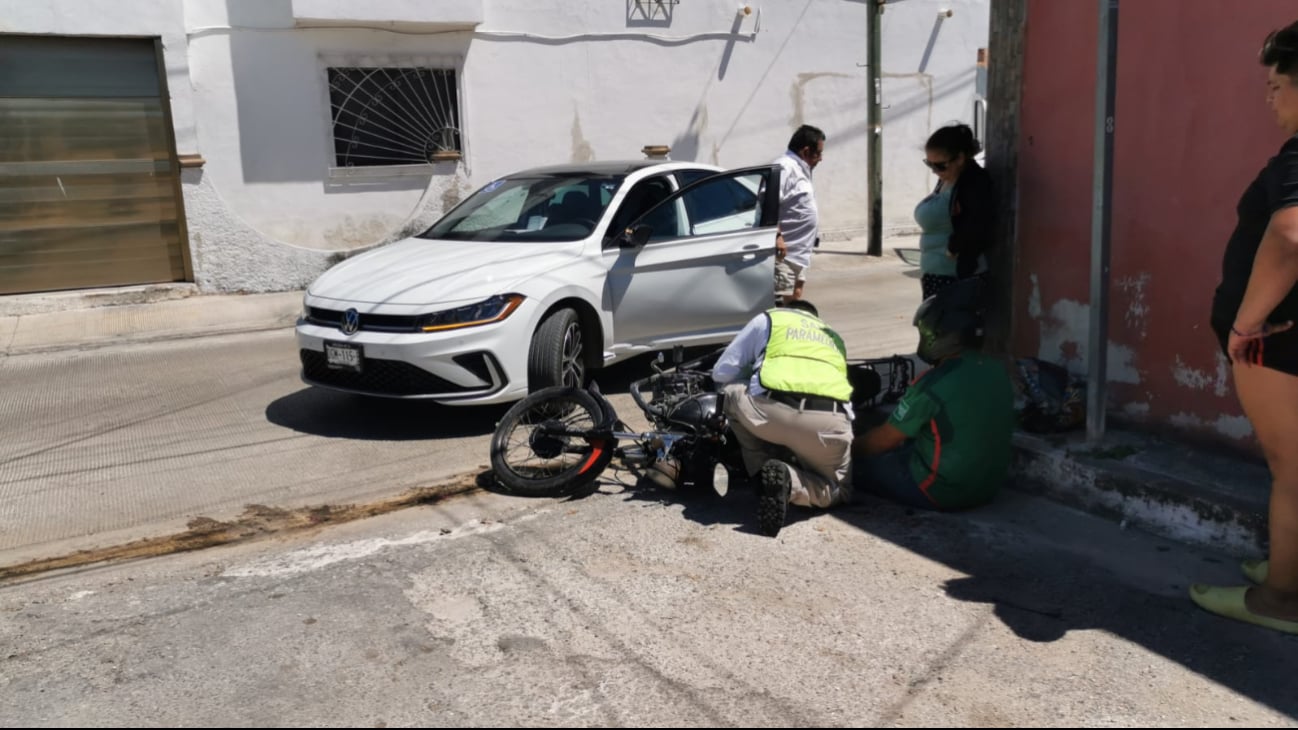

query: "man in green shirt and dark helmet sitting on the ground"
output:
851 279 1015 510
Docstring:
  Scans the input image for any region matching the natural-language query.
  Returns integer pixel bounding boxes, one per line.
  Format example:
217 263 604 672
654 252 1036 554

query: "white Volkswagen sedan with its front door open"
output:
297 161 779 404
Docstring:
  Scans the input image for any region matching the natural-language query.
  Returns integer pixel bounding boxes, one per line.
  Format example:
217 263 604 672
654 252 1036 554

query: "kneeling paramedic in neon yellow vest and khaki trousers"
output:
713 300 854 536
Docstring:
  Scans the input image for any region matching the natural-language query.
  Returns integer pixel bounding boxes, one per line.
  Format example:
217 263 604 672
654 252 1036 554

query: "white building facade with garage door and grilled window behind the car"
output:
0 0 989 295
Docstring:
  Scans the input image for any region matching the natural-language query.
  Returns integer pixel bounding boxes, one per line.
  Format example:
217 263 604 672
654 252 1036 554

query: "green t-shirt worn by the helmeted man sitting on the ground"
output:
889 352 1015 509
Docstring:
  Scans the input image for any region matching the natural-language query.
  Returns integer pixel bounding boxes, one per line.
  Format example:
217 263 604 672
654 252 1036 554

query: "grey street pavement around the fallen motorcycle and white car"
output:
0 245 1298 726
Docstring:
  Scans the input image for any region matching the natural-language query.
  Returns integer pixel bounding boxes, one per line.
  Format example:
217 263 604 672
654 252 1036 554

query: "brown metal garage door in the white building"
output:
0 35 188 294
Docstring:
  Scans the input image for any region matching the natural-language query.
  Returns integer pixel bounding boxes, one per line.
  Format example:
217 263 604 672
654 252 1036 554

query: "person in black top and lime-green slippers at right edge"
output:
1190 22 1298 634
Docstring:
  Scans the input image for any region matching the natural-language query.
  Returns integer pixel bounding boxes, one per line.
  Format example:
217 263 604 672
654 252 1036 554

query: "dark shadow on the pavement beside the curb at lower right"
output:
835 492 1298 717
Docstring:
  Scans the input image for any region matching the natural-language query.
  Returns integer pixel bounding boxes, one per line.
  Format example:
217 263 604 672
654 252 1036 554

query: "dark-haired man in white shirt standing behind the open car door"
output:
775 125 824 300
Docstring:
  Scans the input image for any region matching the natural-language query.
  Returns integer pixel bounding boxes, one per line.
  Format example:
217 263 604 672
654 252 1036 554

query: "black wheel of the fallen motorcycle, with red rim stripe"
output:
491 386 617 496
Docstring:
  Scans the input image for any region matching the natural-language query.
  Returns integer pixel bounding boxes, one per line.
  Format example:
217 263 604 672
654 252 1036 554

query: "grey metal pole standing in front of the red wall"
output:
1086 0 1118 444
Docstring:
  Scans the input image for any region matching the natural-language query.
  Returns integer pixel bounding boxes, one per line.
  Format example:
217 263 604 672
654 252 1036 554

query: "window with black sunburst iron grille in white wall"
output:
328 68 463 168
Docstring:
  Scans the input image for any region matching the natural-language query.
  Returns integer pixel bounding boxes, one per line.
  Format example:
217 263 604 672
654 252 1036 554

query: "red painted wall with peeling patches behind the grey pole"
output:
1012 0 1298 443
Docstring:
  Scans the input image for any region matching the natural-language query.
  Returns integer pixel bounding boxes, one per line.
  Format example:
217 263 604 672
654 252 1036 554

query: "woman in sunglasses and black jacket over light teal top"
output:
915 123 996 299
